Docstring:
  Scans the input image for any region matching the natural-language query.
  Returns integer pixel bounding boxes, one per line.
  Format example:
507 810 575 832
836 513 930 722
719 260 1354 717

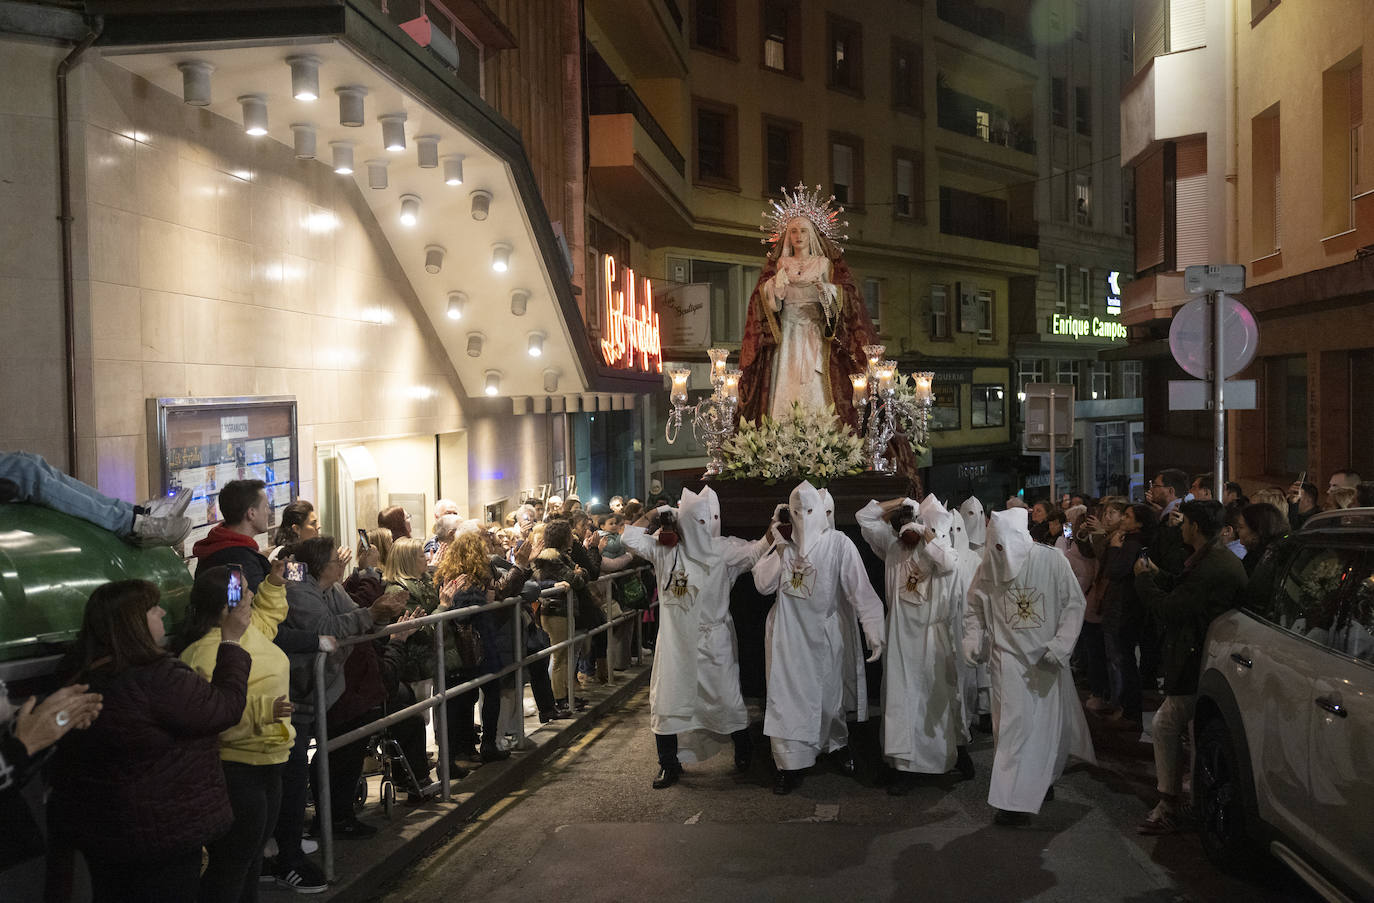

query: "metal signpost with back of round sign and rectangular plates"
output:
1169 264 1260 493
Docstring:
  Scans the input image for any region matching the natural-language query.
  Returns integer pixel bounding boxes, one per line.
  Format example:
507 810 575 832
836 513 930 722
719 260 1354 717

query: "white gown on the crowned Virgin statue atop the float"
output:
765 257 838 419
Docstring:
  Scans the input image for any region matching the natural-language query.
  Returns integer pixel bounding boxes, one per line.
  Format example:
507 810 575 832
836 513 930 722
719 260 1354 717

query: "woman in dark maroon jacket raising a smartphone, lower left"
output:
48 580 253 903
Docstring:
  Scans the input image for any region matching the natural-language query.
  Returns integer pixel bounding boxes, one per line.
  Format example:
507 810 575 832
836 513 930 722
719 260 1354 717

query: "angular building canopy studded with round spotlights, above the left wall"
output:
89 0 662 399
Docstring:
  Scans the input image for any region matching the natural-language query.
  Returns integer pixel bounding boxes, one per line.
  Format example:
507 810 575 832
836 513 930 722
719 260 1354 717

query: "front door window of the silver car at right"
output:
1245 543 1364 645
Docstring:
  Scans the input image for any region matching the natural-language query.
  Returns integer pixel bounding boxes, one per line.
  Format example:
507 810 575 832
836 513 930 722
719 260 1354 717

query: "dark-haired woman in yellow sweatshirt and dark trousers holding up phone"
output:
180 558 295 903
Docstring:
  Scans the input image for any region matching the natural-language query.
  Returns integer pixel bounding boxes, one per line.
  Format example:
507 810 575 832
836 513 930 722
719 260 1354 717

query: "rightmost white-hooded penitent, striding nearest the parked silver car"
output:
963 509 1096 812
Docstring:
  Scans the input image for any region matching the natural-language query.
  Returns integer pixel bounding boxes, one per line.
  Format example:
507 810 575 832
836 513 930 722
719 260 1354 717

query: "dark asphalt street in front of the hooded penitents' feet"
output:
382 691 1316 903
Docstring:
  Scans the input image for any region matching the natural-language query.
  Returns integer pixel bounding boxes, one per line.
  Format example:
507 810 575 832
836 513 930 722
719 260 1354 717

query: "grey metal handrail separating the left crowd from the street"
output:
313 565 657 881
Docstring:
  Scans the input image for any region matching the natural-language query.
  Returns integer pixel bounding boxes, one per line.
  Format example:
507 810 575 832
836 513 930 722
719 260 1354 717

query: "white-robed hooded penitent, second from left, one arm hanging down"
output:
754 482 883 771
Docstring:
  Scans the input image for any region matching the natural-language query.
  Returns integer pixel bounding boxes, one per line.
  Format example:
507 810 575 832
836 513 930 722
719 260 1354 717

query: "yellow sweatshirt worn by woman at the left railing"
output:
181 580 295 766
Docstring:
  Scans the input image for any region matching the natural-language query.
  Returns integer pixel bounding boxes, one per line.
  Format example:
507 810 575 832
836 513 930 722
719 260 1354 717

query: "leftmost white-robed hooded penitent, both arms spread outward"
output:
622 487 768 764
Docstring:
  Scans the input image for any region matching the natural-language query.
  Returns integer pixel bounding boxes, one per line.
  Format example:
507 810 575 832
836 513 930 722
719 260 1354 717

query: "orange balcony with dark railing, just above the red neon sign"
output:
588 84 690 228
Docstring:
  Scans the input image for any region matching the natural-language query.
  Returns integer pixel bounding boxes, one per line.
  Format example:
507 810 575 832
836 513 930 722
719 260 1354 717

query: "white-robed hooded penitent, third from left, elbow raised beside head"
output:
856 495 969 774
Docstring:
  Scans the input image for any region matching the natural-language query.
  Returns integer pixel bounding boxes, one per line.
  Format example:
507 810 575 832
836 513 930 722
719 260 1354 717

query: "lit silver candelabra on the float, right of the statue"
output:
849 345 934 473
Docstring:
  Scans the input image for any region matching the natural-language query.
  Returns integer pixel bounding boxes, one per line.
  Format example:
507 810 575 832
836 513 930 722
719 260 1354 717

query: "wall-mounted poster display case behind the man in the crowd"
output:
147 396 301 554
